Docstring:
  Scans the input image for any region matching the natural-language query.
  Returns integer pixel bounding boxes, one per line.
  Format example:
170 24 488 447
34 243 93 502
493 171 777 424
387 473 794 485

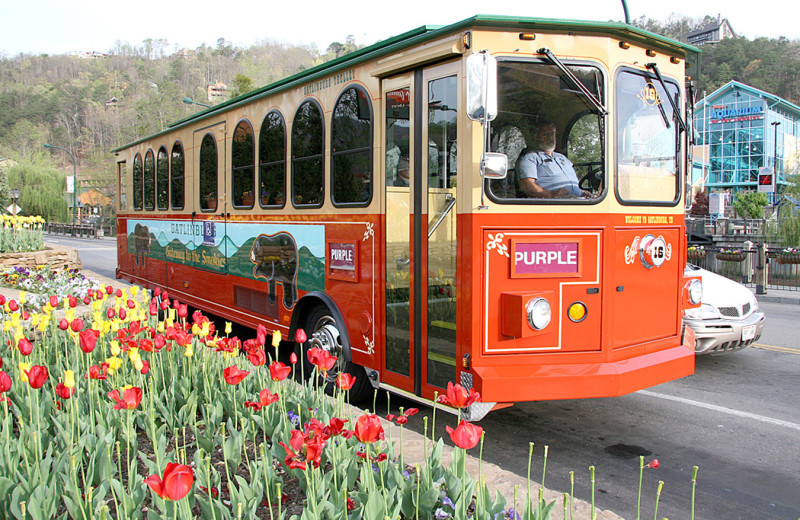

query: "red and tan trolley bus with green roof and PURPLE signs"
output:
115 16 696 419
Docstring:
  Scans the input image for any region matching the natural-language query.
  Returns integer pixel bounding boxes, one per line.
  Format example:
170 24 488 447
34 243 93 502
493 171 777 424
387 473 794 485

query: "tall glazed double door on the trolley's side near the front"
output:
383 63 459 398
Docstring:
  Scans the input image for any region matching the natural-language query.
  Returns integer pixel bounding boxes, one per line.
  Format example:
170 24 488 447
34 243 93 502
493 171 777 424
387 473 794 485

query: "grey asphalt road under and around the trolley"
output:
46 236 800 520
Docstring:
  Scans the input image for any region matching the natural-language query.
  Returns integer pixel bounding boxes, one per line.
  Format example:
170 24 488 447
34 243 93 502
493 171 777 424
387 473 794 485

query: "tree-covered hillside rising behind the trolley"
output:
0 16 800 215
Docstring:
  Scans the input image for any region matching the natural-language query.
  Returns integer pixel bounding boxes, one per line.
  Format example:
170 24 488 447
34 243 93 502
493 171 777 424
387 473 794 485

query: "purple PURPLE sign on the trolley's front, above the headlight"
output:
512 242 578 276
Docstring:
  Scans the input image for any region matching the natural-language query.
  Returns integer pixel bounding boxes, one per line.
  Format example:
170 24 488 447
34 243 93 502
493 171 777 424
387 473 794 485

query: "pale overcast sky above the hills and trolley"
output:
0 0 800 57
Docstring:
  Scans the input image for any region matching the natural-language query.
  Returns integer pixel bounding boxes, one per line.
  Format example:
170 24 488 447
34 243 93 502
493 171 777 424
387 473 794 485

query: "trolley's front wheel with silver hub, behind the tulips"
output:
295 305 372 401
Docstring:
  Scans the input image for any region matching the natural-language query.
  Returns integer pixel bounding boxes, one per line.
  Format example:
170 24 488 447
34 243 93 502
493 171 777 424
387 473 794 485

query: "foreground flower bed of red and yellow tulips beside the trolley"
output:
0 278 692 520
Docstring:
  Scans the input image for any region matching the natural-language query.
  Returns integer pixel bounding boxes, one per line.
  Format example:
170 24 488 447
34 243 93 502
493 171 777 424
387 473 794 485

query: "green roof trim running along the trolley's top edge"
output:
111 15 700 153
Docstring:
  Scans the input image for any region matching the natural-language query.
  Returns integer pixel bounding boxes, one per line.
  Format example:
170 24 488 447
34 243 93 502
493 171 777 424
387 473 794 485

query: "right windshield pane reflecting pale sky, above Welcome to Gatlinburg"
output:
616 70 681 204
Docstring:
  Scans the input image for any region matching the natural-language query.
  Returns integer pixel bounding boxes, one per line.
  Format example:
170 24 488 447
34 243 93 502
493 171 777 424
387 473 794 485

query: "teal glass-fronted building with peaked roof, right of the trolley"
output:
692 81 800 200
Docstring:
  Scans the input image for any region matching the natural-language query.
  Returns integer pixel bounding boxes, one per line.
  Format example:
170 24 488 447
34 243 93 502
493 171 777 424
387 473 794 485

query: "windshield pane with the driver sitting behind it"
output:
488 60 606 204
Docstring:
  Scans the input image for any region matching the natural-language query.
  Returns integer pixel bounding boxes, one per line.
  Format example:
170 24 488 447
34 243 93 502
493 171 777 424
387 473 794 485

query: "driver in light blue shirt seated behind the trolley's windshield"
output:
517 121 592 199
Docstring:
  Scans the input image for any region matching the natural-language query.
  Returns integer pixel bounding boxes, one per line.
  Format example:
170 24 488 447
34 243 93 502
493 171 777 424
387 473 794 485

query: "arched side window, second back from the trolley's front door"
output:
292 100 325 207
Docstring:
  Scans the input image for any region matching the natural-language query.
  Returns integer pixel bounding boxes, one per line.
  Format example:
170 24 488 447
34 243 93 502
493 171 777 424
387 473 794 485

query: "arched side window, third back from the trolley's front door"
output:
258 110 286 208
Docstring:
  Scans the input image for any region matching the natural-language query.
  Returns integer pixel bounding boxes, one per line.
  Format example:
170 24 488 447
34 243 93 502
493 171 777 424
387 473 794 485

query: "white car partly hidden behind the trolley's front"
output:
683 264 764 354
